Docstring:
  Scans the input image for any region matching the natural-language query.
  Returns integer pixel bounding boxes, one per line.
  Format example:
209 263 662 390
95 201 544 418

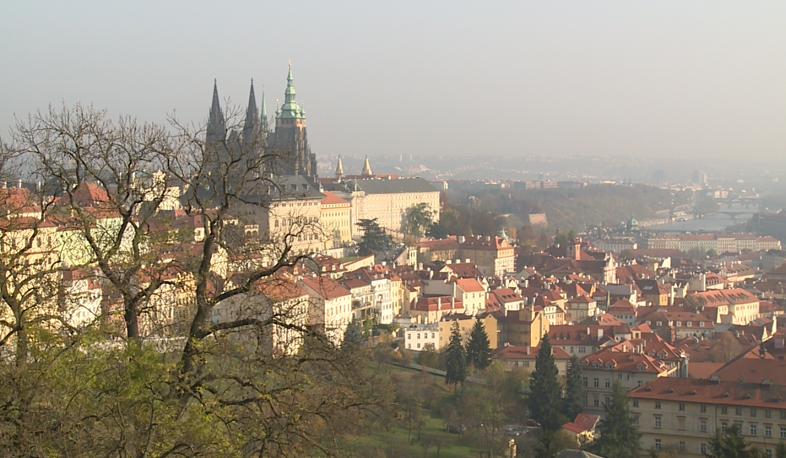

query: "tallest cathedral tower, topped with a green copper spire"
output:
268 65 317 179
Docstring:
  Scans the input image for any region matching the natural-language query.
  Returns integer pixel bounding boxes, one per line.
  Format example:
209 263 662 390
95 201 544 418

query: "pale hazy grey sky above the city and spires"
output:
0 0 786 161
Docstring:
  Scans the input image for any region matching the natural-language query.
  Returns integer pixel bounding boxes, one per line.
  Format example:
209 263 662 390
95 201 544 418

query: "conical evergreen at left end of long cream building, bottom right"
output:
593 381 641 458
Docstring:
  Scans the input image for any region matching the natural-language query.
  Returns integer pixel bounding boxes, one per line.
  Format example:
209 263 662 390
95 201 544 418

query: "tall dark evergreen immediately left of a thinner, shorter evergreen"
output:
528 335 565 431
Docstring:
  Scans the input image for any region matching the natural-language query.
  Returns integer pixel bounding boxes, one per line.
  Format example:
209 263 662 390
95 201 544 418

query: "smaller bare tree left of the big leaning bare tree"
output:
16 105 182 339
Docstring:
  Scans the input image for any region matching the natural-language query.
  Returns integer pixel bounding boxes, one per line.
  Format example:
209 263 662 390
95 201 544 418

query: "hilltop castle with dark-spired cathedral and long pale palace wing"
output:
206 67 440 243
